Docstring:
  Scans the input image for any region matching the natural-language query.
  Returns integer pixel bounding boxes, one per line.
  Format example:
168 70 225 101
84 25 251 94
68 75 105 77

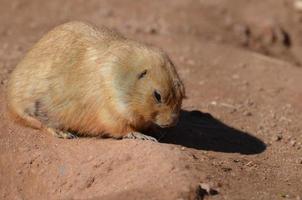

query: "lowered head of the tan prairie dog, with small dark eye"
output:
107 43 185 128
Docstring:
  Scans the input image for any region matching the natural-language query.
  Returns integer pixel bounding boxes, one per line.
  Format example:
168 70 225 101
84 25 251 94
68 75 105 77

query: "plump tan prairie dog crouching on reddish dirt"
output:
7 22 185 140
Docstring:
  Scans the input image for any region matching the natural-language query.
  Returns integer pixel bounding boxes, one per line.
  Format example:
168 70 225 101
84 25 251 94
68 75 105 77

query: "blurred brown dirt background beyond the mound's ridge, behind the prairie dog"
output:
0 0 302 68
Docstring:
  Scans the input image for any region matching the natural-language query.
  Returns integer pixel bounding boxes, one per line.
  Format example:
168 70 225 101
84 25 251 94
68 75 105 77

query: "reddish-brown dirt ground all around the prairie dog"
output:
0 0 302 200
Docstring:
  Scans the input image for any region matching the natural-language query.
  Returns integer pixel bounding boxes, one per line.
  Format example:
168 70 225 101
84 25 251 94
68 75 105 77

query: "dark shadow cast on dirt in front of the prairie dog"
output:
155 110 266 154
